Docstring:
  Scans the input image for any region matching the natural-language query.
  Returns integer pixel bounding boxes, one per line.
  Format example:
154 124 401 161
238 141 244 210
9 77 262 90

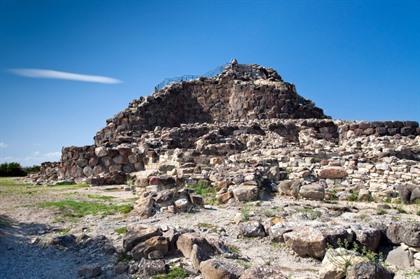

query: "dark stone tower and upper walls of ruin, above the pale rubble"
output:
33 62 420 190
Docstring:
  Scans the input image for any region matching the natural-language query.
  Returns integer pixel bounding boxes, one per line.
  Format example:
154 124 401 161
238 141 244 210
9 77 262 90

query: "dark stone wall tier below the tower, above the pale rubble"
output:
30 119 420 185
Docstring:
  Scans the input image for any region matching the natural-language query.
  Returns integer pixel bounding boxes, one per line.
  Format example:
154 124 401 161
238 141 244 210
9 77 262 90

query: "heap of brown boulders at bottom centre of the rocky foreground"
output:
123 226 286 279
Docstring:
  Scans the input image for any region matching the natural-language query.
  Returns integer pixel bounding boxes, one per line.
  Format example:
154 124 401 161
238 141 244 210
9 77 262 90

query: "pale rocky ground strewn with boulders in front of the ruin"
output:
0 177 420 278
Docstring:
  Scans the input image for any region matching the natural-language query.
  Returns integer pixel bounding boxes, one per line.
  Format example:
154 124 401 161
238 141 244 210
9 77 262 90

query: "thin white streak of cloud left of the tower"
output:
8 69 122 84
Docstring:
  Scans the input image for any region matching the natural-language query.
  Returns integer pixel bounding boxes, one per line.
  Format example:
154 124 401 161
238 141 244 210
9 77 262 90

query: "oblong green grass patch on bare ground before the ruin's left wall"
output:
39 199 133 218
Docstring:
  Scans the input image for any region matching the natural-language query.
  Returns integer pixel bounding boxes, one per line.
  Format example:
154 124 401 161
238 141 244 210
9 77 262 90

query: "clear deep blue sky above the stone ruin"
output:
0 0 420 165
